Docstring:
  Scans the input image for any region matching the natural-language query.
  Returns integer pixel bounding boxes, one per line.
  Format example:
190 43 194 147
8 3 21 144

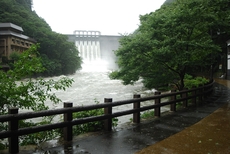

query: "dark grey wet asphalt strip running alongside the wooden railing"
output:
6 79 230 154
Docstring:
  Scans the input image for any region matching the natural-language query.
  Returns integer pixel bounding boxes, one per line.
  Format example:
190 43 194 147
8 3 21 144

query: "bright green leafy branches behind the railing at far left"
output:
0 45 73 149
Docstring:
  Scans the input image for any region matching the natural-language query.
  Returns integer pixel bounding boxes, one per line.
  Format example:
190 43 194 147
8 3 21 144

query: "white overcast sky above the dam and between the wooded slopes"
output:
33 0 165 35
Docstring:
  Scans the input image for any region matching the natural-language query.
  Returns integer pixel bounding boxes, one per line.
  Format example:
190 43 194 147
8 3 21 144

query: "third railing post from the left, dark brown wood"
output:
104 98 113 131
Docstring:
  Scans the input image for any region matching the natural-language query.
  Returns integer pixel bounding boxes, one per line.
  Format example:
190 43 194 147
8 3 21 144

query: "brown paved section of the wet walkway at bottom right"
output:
136 80 230 154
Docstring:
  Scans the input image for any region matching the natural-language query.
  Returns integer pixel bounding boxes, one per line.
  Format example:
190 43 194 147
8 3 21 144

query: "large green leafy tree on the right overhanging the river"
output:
110 0 230 89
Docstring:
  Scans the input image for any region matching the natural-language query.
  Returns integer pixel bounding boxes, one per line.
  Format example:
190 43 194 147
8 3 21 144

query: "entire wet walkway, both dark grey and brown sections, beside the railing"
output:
5 80 230 154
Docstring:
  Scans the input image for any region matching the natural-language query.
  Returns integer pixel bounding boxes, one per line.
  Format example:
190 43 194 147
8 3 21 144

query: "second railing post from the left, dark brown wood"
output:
63 102 73 141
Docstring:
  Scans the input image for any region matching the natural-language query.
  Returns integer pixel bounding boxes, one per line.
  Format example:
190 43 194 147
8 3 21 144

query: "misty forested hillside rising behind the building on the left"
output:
0 0 81 76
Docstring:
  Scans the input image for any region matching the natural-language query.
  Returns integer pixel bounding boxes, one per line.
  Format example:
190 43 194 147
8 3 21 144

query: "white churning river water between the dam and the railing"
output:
42 62 158 124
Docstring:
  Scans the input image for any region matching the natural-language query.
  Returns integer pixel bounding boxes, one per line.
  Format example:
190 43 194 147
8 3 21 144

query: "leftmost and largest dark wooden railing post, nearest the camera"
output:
8 108 19 154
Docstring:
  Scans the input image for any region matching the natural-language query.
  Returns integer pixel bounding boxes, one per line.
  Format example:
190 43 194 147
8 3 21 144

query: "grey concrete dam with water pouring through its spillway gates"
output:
67 30 122 70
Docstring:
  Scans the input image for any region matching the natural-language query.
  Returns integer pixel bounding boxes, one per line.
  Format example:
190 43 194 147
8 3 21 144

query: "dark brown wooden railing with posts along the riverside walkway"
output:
0 81 214 153
